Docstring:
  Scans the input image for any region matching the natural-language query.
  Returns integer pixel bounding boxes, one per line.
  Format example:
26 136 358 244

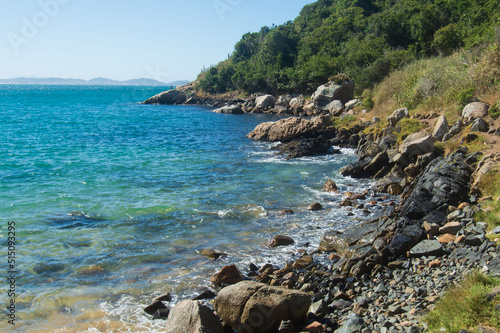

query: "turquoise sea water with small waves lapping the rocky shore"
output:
0 86 367 332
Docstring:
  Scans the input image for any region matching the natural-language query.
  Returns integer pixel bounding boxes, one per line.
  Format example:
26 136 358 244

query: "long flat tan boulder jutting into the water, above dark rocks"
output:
247 116 332 142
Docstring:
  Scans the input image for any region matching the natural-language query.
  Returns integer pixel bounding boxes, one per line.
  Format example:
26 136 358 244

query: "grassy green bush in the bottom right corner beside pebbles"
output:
425 272 500 333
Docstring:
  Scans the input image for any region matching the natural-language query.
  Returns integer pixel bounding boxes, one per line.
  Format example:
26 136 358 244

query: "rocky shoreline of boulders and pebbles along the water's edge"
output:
140 82 500 333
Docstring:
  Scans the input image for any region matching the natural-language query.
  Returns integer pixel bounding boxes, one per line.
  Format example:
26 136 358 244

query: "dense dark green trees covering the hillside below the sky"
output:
198 0 500 96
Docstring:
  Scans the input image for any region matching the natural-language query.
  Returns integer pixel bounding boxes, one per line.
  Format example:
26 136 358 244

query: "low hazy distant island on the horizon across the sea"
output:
0 77 190 87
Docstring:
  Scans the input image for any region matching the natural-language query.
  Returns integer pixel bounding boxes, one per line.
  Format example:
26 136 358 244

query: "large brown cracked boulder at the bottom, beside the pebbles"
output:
214 281 311 333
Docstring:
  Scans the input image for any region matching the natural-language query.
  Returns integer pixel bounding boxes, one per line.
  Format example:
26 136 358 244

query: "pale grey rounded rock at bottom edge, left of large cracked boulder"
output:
166 301 224 333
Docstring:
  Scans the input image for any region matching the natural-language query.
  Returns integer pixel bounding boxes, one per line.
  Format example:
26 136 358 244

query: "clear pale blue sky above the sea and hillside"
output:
0 0 314 82
